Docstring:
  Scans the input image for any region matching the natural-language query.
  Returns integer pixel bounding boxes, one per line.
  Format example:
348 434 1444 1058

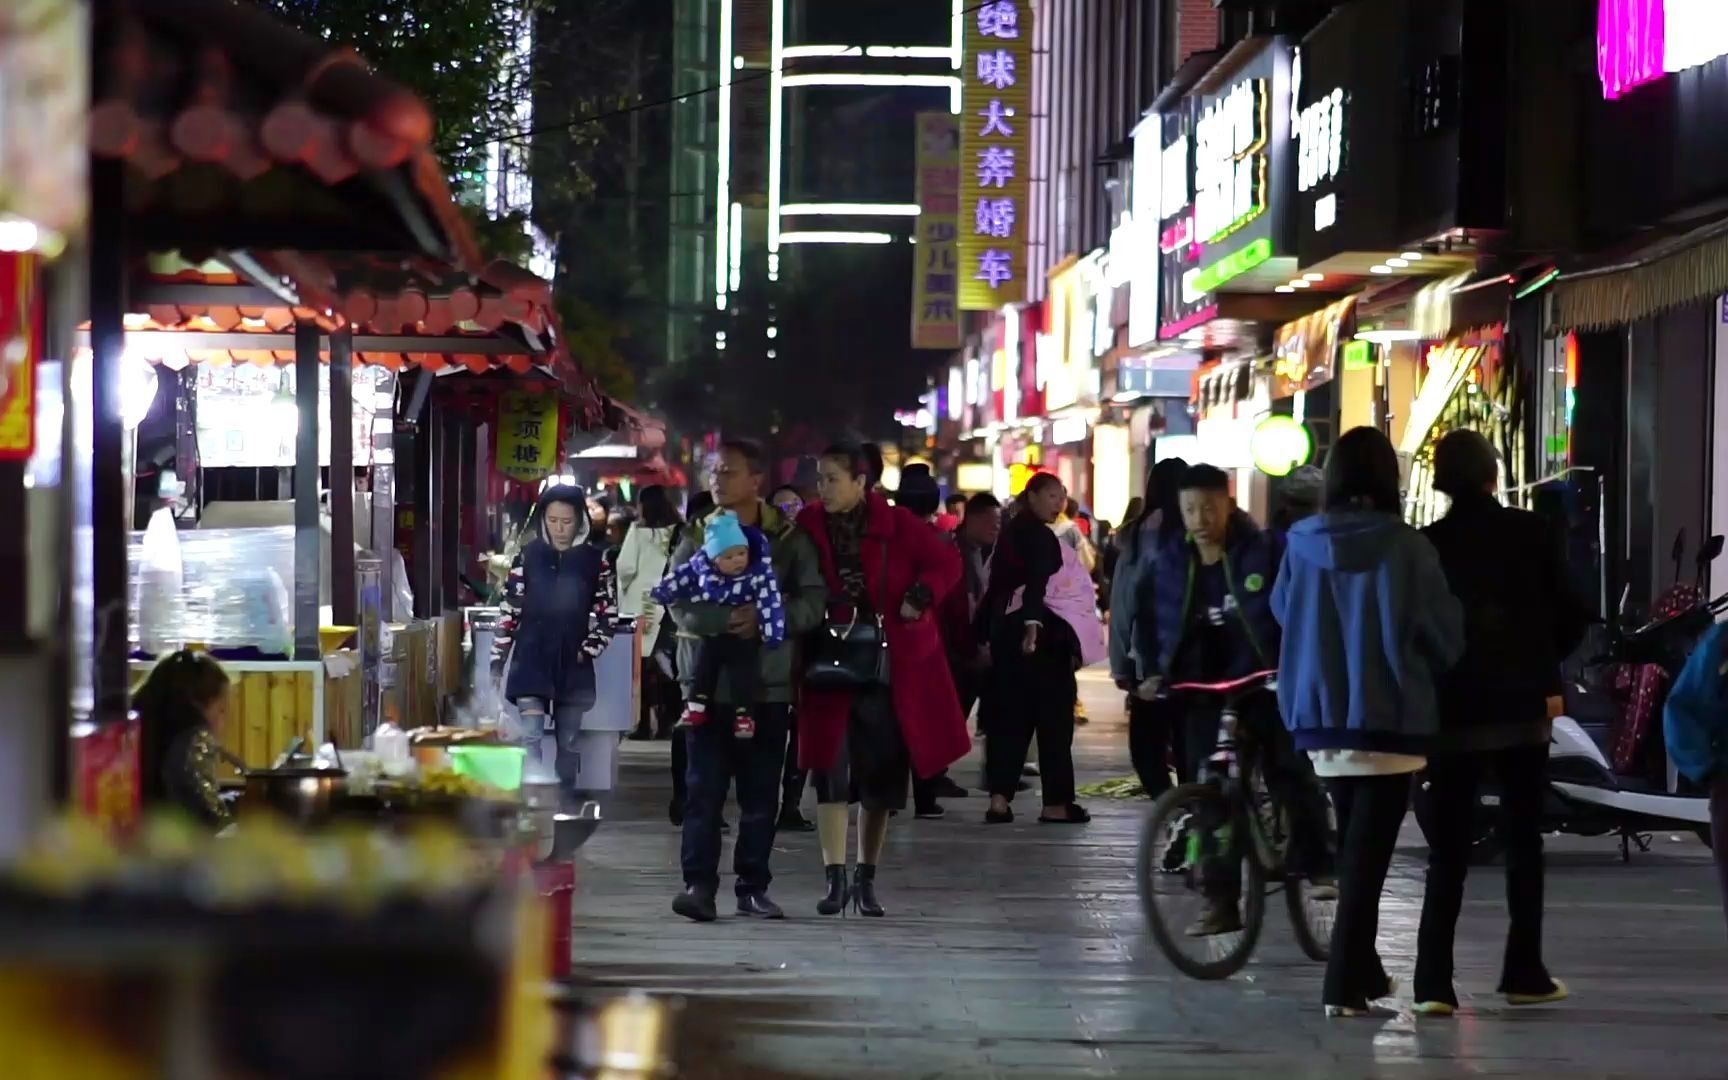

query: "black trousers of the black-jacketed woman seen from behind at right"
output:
1414 743 1552 1004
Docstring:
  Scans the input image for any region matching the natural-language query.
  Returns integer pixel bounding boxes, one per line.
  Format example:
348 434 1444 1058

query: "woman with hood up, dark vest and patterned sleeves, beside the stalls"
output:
492 484 619 790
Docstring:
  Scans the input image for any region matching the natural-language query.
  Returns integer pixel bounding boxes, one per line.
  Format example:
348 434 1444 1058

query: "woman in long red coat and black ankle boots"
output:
798 446 971 916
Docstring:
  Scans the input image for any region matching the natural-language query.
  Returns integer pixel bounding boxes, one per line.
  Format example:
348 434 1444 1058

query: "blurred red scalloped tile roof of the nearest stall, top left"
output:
90 0 484 273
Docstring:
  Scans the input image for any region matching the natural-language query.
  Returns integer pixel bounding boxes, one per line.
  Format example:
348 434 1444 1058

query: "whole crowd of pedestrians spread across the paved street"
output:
470 429 1728 1016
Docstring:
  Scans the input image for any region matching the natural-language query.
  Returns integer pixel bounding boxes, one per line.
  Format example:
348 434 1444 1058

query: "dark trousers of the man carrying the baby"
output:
683 705 791 895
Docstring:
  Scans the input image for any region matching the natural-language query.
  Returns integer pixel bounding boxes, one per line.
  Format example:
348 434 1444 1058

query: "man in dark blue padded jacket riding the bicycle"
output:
1134 465 1329 937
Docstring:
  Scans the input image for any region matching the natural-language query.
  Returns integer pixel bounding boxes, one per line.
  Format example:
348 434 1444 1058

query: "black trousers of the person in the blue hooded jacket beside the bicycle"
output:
1322 772 1410 1007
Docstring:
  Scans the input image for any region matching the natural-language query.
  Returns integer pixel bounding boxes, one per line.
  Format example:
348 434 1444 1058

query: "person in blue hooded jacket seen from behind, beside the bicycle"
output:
1272 427 1464 1016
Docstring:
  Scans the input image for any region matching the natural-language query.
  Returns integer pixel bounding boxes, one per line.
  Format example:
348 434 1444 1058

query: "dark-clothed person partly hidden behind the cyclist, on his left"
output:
1109 458 1187 798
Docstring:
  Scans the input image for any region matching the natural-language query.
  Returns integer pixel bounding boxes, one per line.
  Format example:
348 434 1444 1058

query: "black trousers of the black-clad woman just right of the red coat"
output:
983 634 1080 807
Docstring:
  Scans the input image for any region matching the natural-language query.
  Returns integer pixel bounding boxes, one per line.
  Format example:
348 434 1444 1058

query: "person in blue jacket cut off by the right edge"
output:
1662 622 1728 933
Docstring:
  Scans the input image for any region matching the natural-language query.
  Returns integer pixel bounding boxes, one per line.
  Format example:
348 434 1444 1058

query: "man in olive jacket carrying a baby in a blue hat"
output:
670 441 828 923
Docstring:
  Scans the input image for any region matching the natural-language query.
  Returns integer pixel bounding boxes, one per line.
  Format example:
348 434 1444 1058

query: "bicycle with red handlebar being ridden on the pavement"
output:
1137 670 1337 980
